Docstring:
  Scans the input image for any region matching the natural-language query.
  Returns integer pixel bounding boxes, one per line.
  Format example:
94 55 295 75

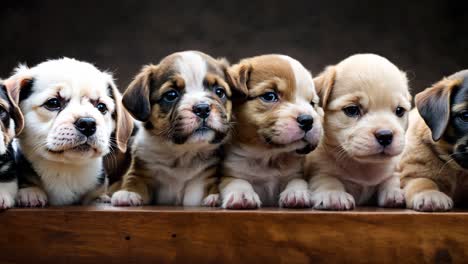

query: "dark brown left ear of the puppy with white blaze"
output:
122 65 158 122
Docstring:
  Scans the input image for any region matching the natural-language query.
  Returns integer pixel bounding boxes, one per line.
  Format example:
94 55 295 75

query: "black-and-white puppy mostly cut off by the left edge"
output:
0 81 23 209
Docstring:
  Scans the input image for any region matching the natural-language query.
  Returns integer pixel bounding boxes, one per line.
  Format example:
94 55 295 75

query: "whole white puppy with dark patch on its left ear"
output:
8 58 133 207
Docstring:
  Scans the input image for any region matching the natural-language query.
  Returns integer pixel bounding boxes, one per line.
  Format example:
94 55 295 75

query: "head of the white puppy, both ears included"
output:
7 58 133 163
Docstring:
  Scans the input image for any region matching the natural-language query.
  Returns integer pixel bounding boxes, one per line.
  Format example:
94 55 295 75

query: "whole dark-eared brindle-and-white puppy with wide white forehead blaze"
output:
112 51 231 206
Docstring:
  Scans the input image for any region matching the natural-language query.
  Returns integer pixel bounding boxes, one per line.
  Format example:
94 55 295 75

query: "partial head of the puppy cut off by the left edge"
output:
0 81 24 155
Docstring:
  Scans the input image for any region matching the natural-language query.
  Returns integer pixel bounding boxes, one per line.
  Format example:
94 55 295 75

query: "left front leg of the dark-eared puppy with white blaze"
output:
111 171 153 206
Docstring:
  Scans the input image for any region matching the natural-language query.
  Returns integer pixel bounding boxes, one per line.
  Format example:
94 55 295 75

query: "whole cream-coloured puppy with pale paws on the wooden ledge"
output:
306 54 411 210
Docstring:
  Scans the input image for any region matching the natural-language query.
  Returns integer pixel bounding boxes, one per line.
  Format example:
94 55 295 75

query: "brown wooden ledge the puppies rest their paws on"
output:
0 206 468 264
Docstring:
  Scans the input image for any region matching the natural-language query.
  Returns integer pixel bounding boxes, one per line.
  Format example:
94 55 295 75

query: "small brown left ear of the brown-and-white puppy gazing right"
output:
227 61 252 98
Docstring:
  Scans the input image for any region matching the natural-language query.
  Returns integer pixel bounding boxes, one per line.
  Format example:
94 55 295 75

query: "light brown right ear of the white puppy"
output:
110 84 133 153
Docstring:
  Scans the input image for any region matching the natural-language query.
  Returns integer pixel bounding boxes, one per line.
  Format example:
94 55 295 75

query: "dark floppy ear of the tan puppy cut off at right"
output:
415 79 461 141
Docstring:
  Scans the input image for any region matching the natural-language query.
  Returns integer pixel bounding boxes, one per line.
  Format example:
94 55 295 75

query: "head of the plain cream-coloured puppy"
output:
314 54 411 162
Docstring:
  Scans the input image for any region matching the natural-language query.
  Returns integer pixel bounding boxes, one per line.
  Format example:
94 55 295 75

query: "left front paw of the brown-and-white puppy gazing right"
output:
220 177 262 209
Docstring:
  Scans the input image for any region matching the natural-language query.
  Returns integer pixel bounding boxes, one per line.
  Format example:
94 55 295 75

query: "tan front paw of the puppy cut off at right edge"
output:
404 178 453 212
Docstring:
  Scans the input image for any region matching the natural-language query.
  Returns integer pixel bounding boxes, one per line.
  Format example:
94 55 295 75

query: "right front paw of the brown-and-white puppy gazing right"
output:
278 179 312 208
